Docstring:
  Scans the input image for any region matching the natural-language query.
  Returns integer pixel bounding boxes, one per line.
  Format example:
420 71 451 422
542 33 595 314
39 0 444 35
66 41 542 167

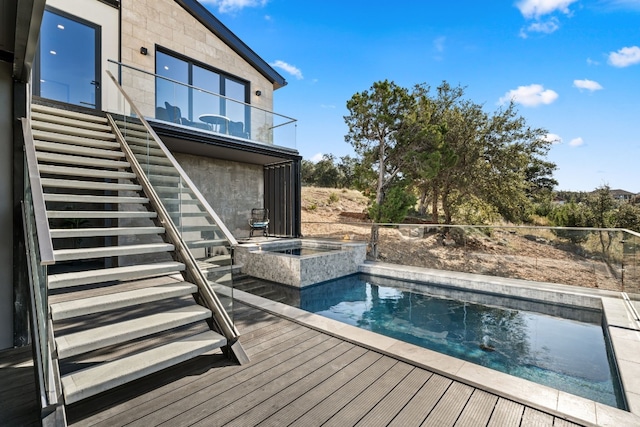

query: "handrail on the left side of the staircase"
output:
20 117 56 265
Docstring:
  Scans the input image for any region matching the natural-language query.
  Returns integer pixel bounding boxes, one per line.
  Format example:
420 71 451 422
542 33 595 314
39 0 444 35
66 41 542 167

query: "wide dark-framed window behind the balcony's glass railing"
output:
156 50 250 138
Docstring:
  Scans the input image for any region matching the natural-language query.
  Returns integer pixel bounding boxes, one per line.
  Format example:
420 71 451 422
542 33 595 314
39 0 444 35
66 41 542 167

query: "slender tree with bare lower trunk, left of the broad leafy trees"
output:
344 80 413 259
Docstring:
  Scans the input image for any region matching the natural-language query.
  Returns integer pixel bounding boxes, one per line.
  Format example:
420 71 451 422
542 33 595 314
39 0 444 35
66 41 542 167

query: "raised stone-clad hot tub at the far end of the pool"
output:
235 239 367 287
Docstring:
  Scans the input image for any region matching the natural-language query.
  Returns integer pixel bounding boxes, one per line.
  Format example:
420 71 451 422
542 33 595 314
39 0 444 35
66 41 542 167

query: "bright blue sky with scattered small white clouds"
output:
200 0 640 192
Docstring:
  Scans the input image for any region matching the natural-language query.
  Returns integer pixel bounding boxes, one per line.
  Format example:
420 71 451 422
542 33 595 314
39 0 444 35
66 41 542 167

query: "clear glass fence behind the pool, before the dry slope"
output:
302 222 640 299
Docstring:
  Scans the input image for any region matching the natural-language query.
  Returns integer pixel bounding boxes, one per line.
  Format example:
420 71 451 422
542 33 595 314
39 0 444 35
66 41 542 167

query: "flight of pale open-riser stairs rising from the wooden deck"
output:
31 105 228 404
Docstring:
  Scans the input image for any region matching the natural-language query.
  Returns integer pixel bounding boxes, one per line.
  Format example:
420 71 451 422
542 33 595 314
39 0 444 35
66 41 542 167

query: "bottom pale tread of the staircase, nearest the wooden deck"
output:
62 331 226 404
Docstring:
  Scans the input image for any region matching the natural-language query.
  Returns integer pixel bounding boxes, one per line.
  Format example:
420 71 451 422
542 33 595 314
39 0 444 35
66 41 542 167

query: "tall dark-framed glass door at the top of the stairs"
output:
34 8 100 108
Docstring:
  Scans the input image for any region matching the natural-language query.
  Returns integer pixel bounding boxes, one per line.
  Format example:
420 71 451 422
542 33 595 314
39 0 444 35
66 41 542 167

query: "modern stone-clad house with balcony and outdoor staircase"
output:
0 0 301 418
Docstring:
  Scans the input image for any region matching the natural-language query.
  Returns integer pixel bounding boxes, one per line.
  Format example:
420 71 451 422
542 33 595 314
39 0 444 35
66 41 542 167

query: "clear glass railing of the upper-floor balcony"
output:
105 61 297 148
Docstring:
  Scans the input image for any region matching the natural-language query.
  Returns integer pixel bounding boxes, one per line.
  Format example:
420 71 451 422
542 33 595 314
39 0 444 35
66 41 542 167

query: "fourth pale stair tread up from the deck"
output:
49 261 185 289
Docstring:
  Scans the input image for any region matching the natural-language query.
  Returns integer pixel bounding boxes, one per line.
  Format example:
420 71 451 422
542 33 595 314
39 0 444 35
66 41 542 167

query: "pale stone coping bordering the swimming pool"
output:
233 262 640 426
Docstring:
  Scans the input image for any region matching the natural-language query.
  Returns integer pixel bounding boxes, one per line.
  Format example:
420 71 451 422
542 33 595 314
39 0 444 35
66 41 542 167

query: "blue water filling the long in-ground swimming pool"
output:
246 275 621 407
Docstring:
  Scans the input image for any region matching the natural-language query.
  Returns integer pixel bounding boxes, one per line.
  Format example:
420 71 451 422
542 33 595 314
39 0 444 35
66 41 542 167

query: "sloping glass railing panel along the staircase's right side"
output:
106 64 234 319
